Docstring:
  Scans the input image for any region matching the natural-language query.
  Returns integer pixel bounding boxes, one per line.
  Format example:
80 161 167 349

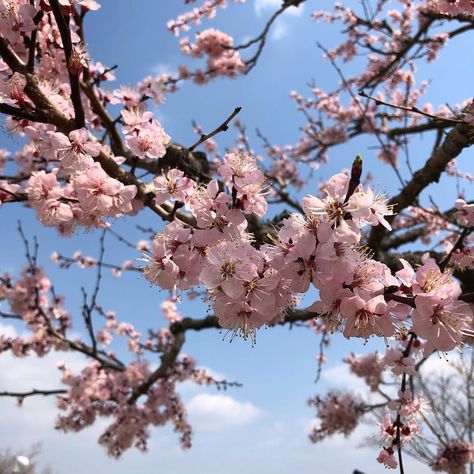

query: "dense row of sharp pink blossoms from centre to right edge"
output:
139 153 472 354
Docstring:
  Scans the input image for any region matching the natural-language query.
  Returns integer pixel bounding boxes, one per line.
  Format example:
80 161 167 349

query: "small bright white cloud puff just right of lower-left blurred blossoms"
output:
187 393 263 431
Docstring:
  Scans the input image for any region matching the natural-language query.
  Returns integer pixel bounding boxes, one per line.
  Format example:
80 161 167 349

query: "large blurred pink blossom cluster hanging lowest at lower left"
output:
57 356 195 457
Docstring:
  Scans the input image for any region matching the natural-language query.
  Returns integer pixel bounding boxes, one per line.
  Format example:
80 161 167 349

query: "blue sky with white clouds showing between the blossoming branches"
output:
0 0 474 474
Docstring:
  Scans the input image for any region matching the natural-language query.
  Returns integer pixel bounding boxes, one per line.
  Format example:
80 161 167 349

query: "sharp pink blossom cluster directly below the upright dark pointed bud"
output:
268 174 398 338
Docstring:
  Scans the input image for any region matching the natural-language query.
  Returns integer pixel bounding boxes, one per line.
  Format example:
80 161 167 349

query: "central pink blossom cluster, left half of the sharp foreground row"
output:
144 153 293 338
